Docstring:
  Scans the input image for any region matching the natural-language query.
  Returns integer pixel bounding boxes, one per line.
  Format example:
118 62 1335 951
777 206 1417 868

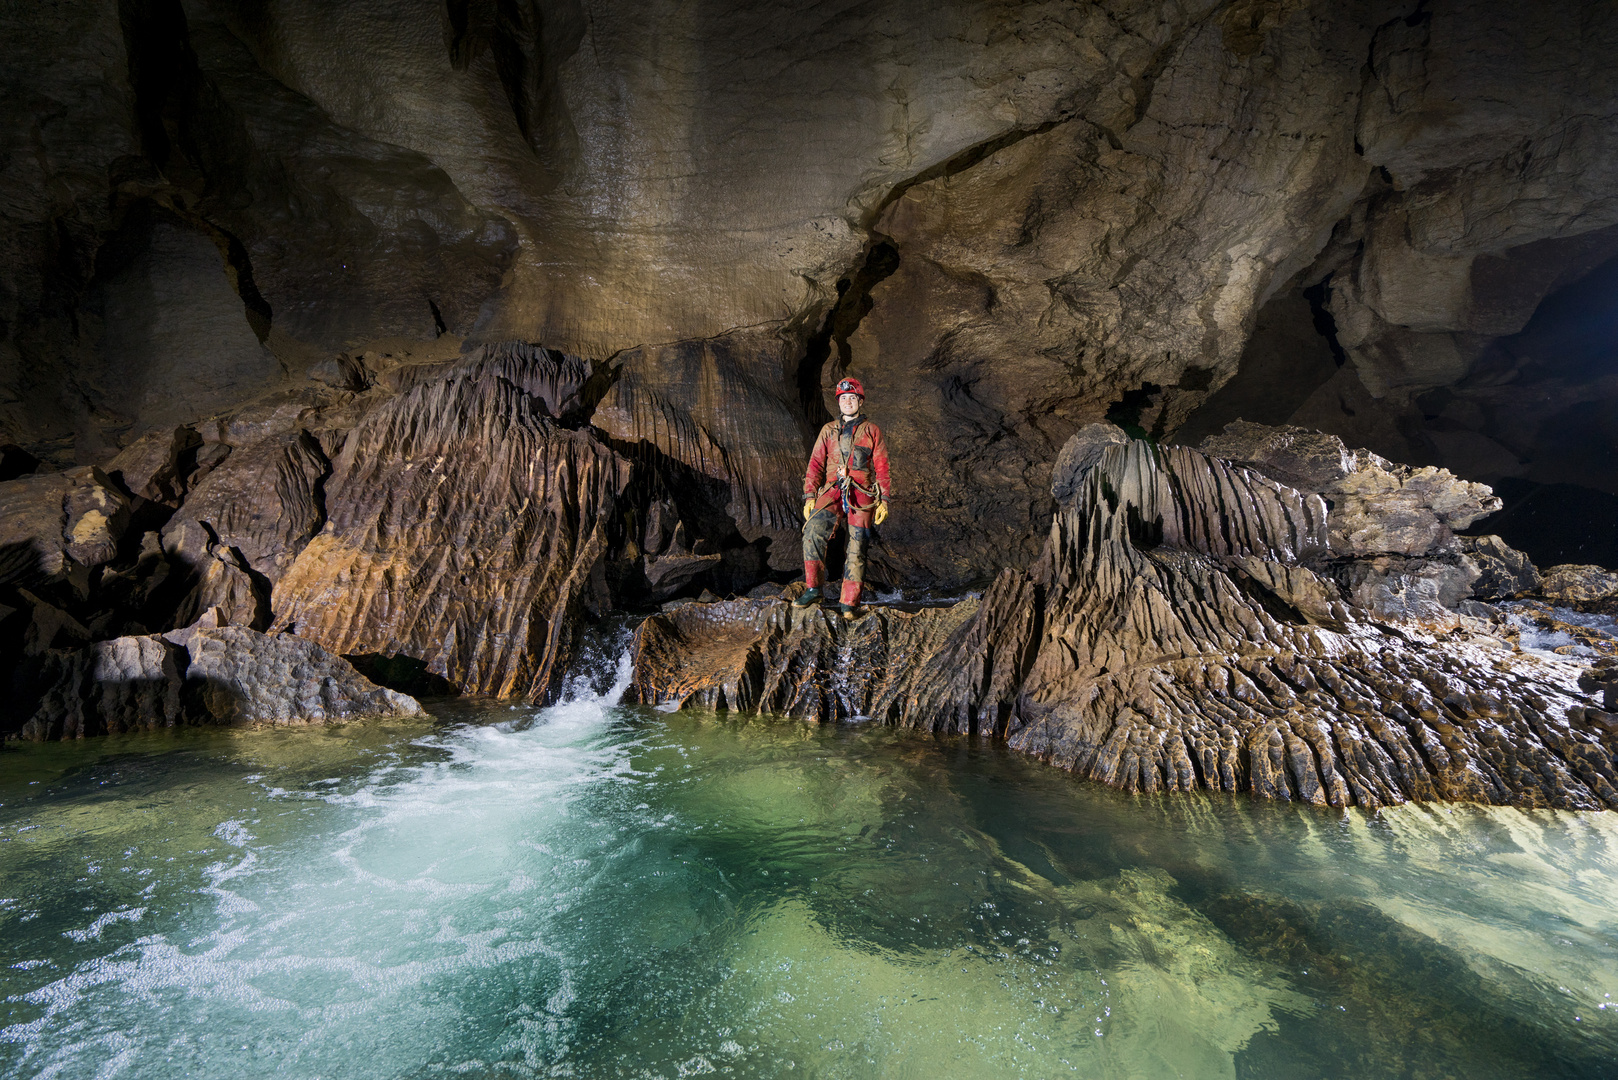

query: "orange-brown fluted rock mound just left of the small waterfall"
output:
273 366 629 699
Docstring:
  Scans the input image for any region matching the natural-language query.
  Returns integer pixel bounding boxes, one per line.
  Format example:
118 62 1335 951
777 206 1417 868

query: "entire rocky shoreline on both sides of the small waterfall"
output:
0 345 1618 810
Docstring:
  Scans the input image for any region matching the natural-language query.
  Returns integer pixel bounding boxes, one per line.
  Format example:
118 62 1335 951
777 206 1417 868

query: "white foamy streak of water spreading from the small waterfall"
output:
0 654 634 1078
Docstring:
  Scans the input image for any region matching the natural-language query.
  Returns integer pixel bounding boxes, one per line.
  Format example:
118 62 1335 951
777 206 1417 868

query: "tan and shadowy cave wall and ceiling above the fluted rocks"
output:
0 0 1618 581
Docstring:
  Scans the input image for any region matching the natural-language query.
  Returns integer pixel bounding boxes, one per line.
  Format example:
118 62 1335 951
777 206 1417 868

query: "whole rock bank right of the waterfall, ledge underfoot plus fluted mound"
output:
634 427 1618 810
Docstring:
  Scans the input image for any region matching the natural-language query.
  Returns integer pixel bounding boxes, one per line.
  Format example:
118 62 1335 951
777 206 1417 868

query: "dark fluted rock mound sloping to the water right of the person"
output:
1011 450 1618 808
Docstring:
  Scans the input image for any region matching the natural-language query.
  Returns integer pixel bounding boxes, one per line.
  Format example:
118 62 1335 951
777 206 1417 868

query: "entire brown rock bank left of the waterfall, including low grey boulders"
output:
0 343 786 738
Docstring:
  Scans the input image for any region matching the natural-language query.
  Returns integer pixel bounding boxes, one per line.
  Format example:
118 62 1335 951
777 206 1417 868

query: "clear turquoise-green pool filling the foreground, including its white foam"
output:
0 654 1618 1080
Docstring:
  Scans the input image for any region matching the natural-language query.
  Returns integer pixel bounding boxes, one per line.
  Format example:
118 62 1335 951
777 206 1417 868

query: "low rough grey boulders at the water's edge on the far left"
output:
21 627 421 742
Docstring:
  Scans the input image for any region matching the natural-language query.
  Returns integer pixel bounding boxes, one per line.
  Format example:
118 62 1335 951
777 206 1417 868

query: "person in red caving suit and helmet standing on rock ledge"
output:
794 379 892 619
